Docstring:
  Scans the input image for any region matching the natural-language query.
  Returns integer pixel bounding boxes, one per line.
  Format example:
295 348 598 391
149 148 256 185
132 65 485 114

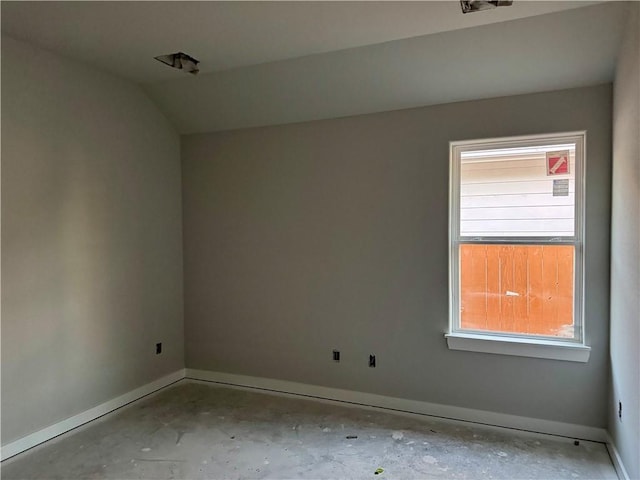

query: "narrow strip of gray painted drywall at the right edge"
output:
608 3 640 479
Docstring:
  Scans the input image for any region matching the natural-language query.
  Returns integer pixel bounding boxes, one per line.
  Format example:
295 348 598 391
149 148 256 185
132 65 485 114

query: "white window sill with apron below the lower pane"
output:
445 333 591 363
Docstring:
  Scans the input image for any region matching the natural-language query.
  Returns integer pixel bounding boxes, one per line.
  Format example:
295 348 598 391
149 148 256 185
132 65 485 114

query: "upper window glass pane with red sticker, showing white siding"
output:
460 143 576 237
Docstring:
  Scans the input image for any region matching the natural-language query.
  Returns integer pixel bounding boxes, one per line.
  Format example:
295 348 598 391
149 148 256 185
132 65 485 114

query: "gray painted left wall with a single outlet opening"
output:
2 37 184 444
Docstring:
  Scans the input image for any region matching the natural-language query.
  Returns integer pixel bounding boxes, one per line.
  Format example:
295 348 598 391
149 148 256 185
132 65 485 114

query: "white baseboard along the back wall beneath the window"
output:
186 368 607 443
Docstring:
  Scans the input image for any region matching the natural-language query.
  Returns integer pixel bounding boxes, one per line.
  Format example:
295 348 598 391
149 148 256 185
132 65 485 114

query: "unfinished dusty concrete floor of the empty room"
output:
1 382 617 480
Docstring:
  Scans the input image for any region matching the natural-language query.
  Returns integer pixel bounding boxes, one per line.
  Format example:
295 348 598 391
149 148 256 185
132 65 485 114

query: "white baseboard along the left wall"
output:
0 369 185 460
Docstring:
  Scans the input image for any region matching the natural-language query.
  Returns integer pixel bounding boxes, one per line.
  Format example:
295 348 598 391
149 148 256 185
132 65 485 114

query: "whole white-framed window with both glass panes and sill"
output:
446 132 589 362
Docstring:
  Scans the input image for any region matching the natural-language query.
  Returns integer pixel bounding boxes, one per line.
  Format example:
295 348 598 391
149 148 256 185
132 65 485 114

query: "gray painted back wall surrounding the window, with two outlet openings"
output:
182 84 612 427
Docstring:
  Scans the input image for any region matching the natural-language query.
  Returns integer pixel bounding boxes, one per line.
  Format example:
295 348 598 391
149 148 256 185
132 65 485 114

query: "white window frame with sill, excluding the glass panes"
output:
445 131 591 362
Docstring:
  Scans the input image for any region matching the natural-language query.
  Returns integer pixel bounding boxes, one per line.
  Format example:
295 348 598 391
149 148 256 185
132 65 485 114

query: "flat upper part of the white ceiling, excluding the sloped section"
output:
2 0 590 83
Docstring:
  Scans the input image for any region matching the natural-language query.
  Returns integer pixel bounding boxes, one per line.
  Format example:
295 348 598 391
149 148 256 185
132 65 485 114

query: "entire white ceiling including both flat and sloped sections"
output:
1 0 625 133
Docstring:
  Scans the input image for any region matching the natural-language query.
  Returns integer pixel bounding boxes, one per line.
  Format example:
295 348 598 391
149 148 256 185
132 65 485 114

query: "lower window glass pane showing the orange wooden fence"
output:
459 244 576 338
